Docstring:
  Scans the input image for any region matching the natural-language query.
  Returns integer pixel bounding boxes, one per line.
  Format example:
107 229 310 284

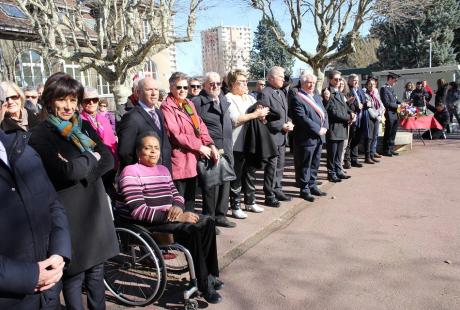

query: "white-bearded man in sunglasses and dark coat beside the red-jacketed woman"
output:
192 72 236 227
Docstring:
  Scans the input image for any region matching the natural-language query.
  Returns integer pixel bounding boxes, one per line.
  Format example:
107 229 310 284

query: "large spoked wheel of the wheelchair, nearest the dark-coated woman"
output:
104 226 167 306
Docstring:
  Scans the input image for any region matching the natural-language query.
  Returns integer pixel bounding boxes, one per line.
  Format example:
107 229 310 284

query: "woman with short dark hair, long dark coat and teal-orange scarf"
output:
29 73 119 309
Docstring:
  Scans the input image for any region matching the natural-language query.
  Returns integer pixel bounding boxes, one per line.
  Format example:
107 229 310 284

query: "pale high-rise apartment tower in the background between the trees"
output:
201 26 252 76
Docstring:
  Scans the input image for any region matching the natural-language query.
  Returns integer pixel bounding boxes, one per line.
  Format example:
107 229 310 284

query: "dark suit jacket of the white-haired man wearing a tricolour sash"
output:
292 91 329 145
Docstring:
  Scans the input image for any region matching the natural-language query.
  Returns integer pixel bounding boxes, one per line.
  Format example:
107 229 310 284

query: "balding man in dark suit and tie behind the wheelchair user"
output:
117 77 171 172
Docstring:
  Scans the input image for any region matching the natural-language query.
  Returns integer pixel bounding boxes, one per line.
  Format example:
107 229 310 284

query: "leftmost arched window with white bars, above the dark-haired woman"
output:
14 50 49 87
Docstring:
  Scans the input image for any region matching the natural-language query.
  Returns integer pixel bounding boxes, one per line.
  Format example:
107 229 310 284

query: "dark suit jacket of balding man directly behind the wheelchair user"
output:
117 105 172 172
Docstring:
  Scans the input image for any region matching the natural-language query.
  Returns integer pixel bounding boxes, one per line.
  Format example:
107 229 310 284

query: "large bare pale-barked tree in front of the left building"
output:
16 0 203 104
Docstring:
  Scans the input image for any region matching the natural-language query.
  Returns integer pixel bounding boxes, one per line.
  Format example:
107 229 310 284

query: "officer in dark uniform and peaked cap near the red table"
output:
380 72 401 157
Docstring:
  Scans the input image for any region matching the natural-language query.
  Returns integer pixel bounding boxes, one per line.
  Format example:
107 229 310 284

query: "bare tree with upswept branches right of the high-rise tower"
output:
250 0 430 87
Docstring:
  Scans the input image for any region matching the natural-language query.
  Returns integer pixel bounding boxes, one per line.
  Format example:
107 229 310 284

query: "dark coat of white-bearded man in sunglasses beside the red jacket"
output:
192 90 233 164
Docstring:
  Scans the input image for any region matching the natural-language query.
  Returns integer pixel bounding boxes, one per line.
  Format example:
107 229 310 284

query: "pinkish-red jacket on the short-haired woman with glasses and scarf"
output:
161 96 213 180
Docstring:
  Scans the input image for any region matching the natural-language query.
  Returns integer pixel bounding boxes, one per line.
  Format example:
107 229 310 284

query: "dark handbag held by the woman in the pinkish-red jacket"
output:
197 156 236 188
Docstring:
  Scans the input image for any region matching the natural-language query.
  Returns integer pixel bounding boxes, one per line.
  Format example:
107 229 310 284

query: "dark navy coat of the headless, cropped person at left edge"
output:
0 130 71 310
